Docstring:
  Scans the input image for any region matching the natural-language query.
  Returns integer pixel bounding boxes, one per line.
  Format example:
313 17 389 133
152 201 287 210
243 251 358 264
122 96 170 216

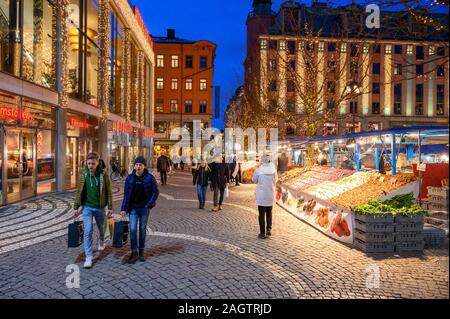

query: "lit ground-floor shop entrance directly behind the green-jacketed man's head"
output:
65 112 99 189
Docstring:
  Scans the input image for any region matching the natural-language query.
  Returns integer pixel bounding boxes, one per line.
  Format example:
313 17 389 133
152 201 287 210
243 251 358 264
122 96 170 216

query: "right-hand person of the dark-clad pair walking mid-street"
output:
210 157 230 212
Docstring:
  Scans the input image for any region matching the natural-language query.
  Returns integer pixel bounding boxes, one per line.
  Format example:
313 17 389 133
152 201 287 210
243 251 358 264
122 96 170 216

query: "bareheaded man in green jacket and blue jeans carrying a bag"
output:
73 153 113 268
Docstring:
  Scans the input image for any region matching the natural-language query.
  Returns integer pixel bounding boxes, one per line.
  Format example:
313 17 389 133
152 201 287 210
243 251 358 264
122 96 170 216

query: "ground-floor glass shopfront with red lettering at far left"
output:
0 92 56 204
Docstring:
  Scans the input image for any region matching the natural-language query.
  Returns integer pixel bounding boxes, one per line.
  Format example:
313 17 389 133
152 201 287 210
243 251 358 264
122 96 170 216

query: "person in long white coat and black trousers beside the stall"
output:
252 155 278 239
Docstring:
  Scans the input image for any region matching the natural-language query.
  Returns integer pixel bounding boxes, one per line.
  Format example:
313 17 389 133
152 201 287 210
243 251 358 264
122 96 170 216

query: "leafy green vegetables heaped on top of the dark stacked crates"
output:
353 193 425 215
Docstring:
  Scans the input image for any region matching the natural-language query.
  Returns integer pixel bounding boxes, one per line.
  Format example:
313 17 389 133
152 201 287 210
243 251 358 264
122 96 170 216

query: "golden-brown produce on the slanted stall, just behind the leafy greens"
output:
328 174 416 209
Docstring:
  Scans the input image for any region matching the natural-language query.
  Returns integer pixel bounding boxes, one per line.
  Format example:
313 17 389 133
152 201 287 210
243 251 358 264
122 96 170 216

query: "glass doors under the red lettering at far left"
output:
3 130 36 203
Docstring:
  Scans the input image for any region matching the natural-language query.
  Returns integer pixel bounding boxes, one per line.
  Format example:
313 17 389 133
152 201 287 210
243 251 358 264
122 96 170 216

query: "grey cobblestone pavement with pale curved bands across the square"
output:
0 172 449 299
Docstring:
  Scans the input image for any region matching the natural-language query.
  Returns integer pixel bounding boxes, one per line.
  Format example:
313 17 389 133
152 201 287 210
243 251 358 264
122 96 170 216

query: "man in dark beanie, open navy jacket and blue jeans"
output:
121 156 159 264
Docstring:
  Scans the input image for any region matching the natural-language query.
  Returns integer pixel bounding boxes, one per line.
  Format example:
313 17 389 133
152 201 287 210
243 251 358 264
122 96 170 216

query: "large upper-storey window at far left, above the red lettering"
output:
0 0 55 89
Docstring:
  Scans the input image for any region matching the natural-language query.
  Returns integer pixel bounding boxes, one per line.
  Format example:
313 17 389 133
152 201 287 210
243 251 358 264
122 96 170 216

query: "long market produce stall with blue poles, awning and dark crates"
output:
275 127 448 252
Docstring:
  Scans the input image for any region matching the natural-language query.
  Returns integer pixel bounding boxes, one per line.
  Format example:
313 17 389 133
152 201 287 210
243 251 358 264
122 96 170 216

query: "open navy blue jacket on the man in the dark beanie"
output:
121 169 159 213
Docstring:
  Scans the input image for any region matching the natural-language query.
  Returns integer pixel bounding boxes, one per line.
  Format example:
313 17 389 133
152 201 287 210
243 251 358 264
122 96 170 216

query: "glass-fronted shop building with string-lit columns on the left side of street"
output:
0 0 154 205
